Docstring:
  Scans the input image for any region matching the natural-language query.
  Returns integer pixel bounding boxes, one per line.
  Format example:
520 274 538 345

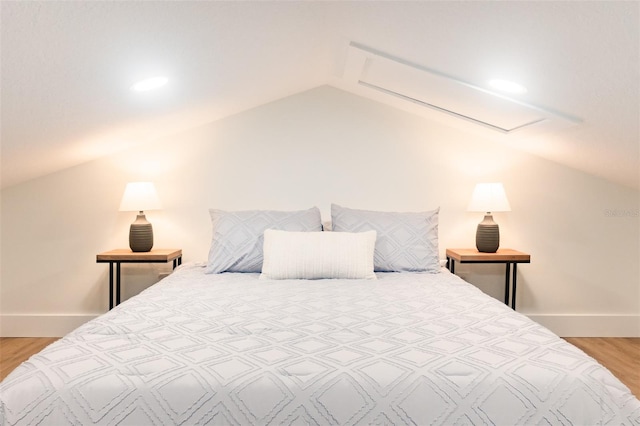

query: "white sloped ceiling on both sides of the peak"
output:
0 1 640 188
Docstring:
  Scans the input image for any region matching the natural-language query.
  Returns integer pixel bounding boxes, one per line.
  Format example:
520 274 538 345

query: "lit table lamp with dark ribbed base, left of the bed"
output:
120 182 161 252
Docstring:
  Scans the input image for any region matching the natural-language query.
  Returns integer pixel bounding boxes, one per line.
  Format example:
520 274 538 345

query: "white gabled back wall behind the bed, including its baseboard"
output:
0 87 640 336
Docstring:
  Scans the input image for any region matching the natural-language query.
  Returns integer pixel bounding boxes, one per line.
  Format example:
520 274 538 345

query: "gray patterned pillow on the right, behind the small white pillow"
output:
331 204 440 273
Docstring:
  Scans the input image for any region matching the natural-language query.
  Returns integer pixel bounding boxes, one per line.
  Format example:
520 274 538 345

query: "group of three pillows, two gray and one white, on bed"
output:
205 204 440 279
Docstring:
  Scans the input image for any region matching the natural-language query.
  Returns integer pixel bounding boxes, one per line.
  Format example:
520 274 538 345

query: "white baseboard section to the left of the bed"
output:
0 314 98 337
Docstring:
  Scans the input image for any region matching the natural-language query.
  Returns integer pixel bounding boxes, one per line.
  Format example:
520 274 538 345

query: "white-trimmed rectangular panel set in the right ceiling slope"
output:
343 42 580 135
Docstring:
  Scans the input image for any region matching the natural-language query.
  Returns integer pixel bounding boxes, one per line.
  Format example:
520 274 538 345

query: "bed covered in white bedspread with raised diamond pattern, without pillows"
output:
0 264 640 425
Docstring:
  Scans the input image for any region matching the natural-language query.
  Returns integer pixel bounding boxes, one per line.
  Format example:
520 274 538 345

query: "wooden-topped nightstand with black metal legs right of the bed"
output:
446 248 531 311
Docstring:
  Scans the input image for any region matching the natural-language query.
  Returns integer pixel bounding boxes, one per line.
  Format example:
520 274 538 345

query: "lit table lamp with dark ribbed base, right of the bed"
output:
467 183 511 253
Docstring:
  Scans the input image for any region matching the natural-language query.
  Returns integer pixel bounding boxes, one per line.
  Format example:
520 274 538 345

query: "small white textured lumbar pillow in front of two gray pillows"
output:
260 229 376 280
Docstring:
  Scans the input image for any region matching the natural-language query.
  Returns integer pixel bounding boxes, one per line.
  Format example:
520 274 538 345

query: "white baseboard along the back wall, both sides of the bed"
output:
0 314 640 337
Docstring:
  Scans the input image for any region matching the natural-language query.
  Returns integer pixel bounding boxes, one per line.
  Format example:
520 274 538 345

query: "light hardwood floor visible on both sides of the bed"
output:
0 337 640 399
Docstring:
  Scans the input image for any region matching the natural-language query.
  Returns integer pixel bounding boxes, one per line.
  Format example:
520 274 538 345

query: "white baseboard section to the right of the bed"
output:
525 314 640 337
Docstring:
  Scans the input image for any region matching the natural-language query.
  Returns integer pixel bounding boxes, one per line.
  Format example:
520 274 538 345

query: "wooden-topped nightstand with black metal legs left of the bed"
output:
96 249 182 309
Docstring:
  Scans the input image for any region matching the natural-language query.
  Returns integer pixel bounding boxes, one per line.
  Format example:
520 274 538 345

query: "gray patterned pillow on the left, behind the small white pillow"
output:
205 207 322 274
